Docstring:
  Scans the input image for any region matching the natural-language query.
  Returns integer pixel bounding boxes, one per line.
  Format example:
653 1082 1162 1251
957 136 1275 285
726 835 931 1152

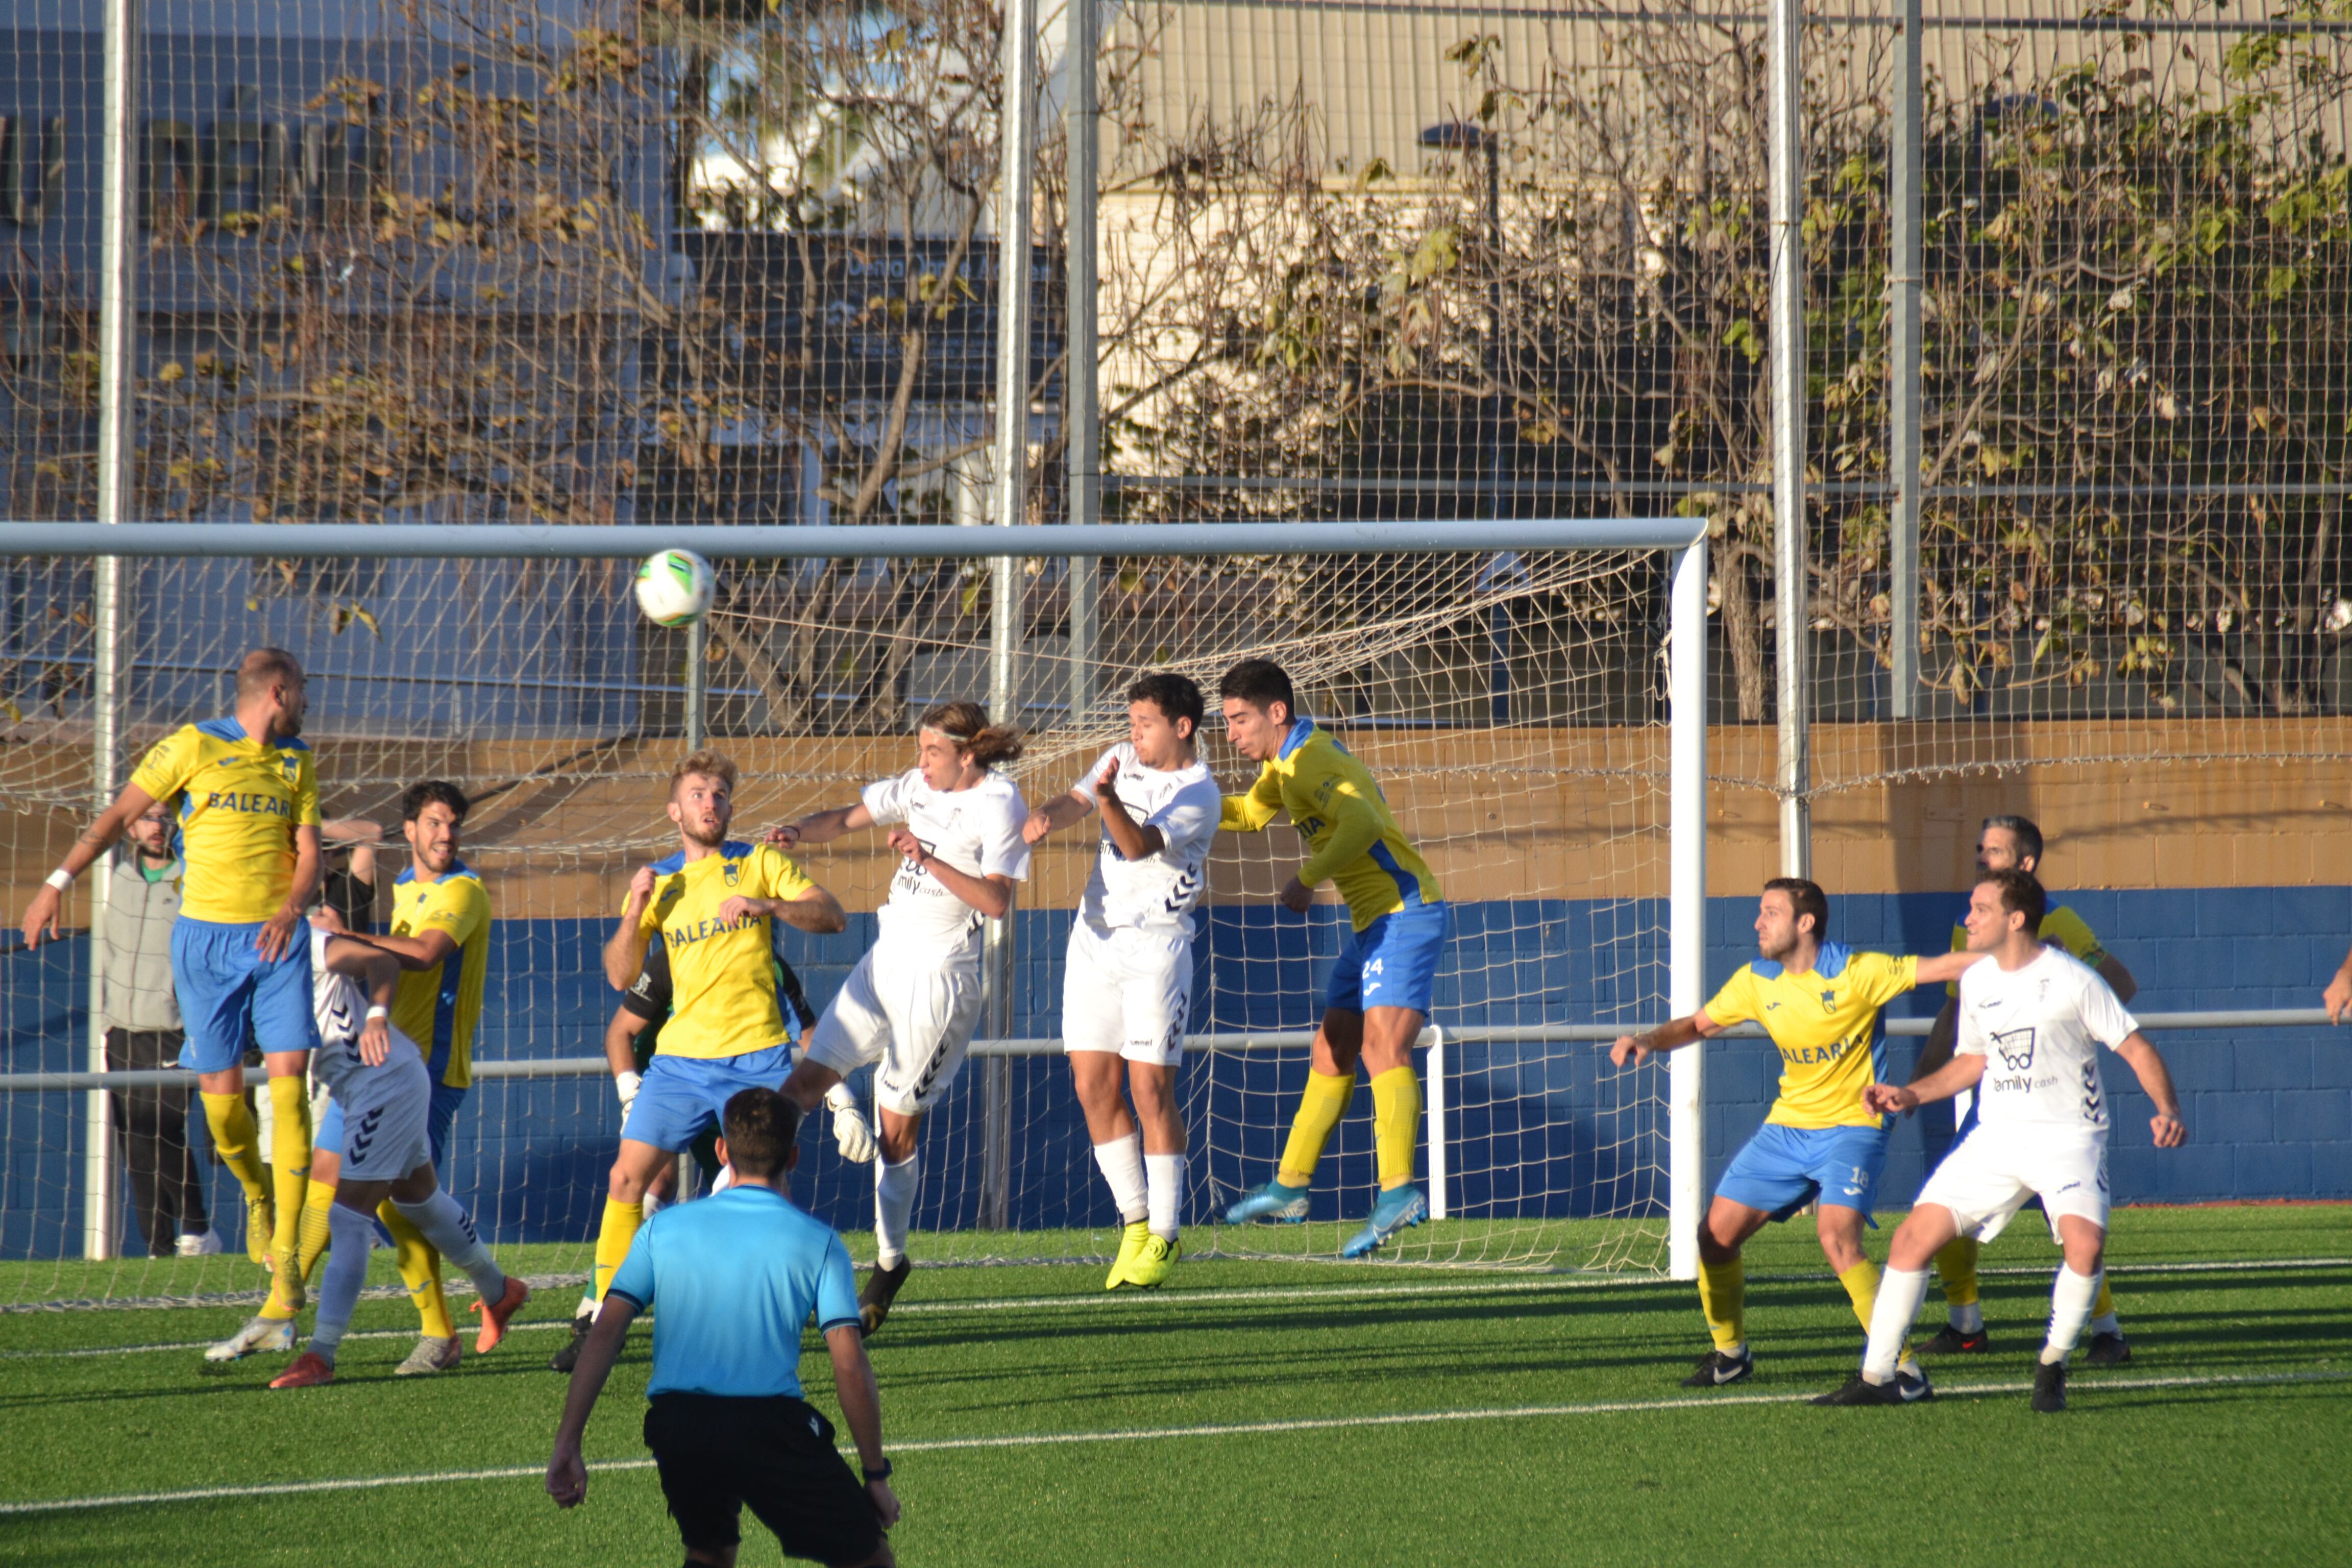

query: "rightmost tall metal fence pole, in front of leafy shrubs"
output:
1886 0 1926 719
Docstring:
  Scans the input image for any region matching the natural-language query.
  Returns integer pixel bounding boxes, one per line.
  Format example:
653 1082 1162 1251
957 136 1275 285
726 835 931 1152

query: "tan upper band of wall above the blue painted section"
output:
0 719 2352 917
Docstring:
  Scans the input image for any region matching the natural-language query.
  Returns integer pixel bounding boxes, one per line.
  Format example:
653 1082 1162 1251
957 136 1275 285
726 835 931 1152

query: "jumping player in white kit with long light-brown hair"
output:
769 703 1028 1333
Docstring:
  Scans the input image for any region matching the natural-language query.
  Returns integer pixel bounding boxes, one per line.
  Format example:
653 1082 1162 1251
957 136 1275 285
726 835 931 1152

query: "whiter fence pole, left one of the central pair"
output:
981 0 1037 1230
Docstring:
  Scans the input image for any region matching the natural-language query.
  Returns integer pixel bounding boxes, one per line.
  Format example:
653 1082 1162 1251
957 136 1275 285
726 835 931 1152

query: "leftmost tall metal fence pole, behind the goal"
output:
82 0 143 1258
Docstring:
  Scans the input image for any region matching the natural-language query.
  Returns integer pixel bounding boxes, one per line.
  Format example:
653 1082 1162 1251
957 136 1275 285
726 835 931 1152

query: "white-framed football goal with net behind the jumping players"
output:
0 517 1707 1297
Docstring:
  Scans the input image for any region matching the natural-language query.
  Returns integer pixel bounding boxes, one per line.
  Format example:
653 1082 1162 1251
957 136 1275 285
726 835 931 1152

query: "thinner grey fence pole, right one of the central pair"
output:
1061 0 1103 724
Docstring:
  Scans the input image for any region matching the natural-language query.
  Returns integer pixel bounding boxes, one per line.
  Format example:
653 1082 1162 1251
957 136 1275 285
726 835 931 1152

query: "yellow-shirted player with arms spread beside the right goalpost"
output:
1609 877 1983 1399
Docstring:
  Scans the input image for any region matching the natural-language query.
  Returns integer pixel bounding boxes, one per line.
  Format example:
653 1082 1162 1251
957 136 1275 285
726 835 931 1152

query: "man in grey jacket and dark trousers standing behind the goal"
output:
106 802 221 1258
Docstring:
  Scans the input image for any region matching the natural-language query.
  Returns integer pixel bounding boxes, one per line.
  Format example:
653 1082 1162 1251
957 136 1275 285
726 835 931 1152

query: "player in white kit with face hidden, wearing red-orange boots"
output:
205 917 531 1389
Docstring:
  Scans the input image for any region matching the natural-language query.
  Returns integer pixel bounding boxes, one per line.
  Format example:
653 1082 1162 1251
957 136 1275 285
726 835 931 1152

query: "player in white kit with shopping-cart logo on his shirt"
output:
1816 870 2187 1410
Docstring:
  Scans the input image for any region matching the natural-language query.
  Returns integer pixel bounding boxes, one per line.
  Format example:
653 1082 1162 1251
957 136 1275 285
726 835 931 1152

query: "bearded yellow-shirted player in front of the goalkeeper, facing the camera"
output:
595 750 849 1300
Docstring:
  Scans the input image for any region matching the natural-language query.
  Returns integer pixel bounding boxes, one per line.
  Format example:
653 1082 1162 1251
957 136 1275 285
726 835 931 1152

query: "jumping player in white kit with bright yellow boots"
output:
1021 675 1226 1291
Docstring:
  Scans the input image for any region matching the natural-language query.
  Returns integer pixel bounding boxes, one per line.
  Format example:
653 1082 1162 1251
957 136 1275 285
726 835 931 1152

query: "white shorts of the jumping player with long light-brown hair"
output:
807 938 981 1117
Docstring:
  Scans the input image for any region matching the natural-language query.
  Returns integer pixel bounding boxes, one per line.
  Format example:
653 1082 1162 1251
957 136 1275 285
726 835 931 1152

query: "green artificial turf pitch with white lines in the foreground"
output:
0 1206 2352 1568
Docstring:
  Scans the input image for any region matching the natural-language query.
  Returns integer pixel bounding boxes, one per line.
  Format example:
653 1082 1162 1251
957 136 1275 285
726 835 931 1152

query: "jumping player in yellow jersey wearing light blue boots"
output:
1218 658 1449 1258
